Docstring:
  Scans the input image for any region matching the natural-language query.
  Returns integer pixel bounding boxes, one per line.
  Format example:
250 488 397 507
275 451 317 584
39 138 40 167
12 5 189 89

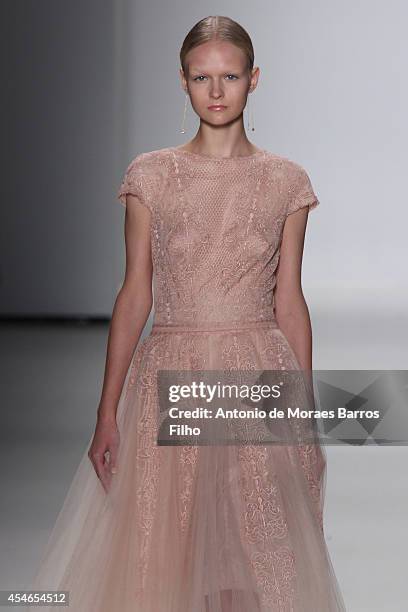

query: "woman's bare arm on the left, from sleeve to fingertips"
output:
88 194 153 489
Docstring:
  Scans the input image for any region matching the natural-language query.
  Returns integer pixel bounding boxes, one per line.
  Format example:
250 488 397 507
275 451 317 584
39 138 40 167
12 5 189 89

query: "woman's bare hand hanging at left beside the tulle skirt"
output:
88 417 120 493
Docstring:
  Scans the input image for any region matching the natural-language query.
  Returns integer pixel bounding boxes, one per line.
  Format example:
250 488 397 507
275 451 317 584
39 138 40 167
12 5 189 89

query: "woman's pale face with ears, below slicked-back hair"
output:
180 41 259 125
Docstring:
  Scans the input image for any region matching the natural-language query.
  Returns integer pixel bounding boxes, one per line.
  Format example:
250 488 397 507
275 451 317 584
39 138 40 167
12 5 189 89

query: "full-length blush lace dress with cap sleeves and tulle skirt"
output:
27 147 345 612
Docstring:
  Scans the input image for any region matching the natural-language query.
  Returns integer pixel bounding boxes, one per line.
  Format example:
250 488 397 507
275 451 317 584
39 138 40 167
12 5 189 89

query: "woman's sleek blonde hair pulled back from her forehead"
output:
180 15 254 74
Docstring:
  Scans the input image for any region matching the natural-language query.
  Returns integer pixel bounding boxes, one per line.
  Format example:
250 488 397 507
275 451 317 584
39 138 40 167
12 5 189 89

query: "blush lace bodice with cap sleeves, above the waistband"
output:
118 147 319 325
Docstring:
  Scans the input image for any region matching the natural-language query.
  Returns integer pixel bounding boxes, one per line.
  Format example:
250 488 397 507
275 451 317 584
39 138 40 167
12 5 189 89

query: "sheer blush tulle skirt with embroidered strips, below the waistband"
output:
29 321 345 612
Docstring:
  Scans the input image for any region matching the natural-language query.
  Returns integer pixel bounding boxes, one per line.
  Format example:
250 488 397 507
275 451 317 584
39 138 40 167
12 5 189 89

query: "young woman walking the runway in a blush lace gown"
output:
29 17 345 612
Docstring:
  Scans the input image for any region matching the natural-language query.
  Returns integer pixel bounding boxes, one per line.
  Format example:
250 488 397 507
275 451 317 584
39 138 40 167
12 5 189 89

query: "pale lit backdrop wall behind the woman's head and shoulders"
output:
116 0 408 315
